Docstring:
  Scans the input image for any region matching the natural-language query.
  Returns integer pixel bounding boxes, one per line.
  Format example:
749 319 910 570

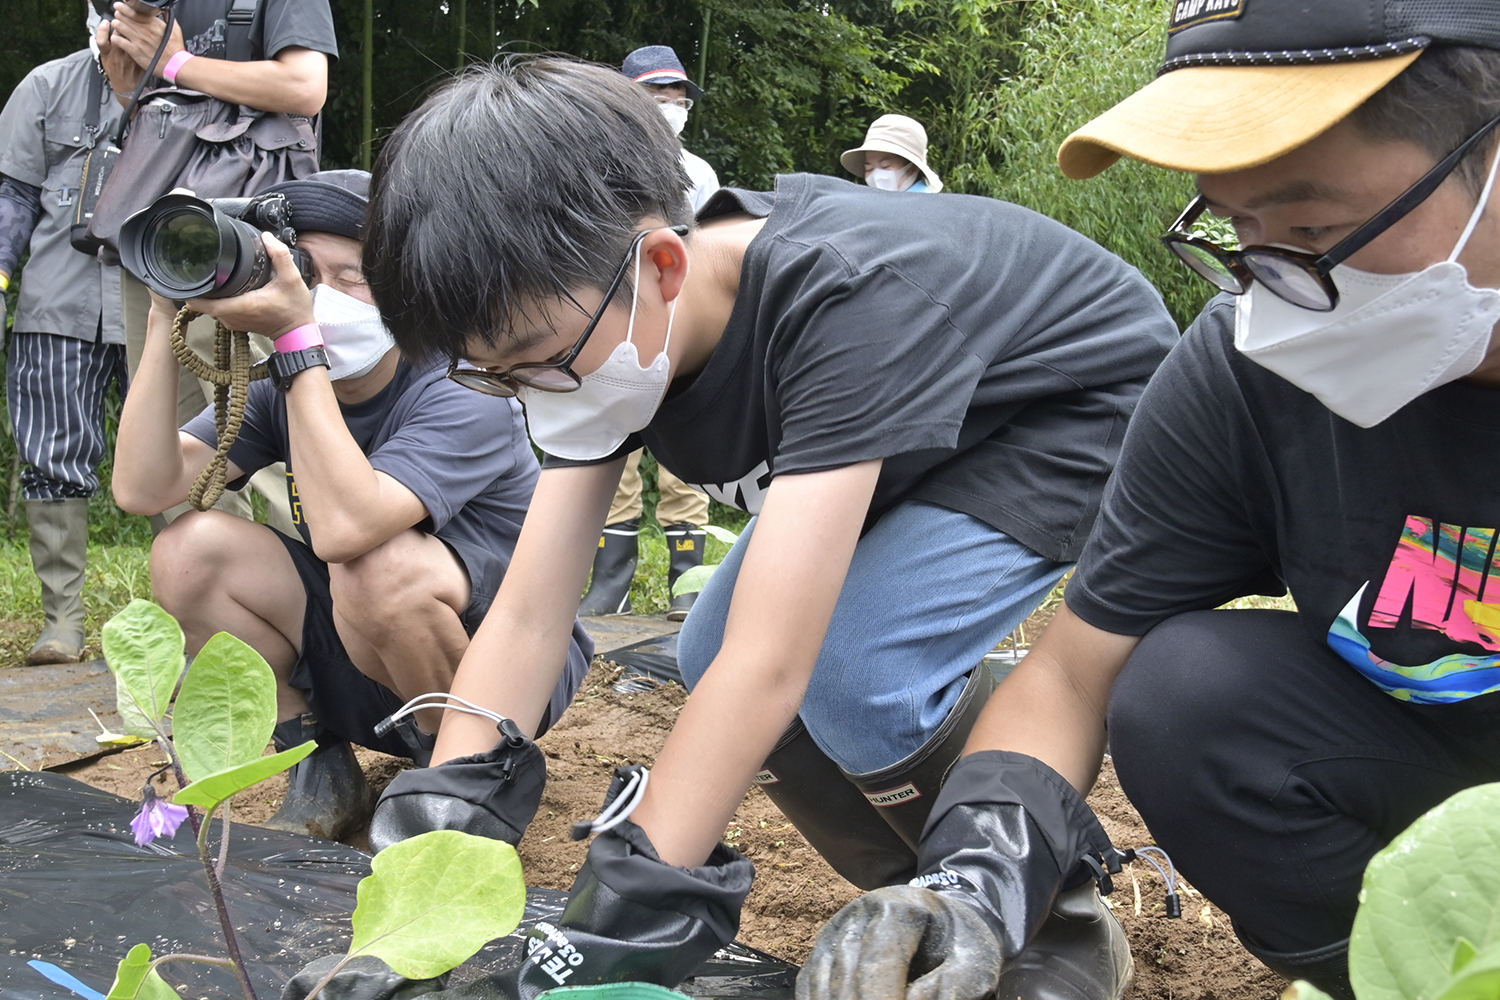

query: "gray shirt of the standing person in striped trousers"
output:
0 49 125 343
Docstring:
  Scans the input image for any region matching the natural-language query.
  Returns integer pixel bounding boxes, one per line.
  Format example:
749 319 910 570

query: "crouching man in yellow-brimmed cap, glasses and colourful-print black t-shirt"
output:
798 0 1500 1000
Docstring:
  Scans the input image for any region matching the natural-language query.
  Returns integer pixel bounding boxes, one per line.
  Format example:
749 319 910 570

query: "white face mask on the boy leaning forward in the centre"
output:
519 244 677 462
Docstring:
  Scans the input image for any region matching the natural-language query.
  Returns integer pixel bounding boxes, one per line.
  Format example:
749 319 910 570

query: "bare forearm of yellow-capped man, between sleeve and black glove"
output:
965 606 1140 795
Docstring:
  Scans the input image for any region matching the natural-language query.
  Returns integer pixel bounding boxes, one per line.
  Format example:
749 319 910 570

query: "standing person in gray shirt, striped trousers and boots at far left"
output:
0 21 126 666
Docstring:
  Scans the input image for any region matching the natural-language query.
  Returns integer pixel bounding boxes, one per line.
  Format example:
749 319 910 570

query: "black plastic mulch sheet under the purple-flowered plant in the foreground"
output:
0 771 797 1000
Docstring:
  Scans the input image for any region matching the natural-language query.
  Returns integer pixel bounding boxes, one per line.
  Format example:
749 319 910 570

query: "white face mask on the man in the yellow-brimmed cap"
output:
1235 148 1500 427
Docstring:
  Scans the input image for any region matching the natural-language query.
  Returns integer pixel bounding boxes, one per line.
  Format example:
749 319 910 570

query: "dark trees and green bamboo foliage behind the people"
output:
0 0 1206 322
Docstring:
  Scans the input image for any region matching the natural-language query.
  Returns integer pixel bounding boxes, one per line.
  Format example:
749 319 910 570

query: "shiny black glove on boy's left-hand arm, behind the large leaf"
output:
371 718 548 852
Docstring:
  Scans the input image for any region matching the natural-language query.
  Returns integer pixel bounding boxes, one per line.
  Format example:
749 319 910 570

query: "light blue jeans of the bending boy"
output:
677 502 1068 774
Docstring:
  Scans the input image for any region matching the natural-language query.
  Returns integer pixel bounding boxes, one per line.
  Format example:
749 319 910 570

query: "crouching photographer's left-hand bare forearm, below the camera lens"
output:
111 309 197 514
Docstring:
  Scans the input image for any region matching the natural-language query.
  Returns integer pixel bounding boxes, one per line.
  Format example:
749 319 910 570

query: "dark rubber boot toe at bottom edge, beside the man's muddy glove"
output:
995 879 1136 1000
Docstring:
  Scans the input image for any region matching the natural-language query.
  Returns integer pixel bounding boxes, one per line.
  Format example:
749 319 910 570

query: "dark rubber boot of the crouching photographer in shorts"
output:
261 715 375 840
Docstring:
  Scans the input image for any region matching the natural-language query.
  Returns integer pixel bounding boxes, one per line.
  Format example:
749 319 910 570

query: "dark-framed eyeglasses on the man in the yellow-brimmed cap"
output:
1161 107 1500 312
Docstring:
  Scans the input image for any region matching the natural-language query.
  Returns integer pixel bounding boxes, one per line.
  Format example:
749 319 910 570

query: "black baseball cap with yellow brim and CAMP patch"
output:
1058 0 1500 178
